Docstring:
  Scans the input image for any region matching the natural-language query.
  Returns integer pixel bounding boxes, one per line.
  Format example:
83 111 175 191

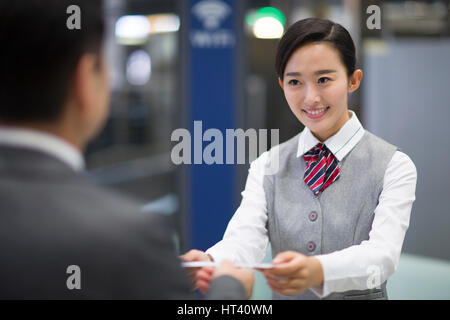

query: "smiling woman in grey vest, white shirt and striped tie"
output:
180 18 417 299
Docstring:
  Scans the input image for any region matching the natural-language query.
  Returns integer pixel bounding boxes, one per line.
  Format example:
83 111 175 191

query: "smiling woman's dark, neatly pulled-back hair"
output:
275 18 356 80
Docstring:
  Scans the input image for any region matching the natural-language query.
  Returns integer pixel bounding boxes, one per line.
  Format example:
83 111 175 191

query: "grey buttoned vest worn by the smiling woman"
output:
263 131 397 299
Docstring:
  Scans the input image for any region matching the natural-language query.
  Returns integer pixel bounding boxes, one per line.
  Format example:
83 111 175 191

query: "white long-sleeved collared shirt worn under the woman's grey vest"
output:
206 111 417 297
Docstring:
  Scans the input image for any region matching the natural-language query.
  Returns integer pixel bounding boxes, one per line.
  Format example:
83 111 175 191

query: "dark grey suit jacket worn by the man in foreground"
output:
0 146 245 299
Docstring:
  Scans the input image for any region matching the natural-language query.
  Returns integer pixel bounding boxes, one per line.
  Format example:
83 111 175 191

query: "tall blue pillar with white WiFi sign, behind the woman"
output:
187 0 242 250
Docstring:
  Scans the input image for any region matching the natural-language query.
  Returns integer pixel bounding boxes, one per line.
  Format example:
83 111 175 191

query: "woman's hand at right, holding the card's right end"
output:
260 251 323 295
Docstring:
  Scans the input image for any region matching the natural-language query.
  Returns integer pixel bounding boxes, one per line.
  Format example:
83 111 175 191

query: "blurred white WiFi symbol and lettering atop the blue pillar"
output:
190 0 236 48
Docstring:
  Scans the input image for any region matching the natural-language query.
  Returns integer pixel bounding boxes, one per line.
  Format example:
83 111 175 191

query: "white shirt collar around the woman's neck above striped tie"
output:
297 110 364 161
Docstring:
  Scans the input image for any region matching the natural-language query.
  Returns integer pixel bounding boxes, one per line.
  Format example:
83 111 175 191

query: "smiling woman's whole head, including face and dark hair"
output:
276 19 362 141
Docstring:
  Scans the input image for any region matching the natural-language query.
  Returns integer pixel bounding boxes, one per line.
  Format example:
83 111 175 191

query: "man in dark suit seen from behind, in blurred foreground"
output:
0 0 254 299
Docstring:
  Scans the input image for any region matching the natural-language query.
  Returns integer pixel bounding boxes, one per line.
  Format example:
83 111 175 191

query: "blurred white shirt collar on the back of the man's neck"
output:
0 126 85 171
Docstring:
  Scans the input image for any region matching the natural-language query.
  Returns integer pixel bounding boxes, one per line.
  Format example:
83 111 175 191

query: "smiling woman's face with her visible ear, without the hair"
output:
279 42 362 141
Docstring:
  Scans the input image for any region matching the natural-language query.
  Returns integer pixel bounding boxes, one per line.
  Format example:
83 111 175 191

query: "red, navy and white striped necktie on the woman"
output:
303 143 340 196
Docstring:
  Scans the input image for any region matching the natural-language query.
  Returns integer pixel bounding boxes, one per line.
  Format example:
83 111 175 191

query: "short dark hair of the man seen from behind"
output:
0 0 104 122
